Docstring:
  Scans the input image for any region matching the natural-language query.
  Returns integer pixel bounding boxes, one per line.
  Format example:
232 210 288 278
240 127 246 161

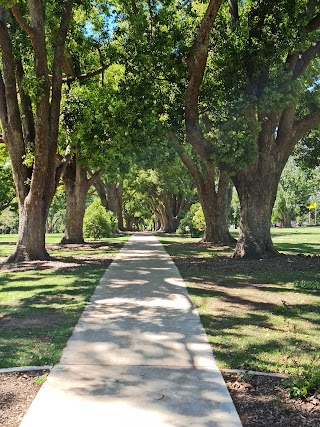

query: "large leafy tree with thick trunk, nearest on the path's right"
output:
204 0 320 258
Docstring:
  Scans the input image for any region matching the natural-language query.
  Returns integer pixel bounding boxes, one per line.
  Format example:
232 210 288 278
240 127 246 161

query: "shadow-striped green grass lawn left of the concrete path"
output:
0 235 130 368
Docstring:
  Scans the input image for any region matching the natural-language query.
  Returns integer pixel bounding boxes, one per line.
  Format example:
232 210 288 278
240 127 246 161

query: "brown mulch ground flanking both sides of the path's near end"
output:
0 372 320 427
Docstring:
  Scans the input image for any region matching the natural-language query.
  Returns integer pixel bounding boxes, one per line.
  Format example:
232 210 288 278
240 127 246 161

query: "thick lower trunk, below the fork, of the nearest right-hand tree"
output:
234 169 280 259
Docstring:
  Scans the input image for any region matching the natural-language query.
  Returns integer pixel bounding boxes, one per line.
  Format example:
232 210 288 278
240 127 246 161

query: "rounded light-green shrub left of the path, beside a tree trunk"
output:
83 199 117 240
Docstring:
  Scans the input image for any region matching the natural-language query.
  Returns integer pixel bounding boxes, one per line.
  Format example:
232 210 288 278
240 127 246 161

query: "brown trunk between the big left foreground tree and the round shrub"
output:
61 156 92 244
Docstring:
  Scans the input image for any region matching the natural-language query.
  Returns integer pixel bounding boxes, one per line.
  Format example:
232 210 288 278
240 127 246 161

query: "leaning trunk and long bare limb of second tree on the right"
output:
181 0 238 244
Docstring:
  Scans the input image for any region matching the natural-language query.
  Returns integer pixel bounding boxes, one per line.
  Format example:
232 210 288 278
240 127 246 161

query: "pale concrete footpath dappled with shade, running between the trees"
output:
21 234 242 427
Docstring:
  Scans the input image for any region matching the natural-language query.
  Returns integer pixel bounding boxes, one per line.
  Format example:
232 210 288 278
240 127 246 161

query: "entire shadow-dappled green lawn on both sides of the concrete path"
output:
0 227 320 373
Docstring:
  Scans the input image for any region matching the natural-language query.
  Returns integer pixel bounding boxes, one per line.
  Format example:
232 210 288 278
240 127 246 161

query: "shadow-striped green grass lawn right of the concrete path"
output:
160 227 320 374
